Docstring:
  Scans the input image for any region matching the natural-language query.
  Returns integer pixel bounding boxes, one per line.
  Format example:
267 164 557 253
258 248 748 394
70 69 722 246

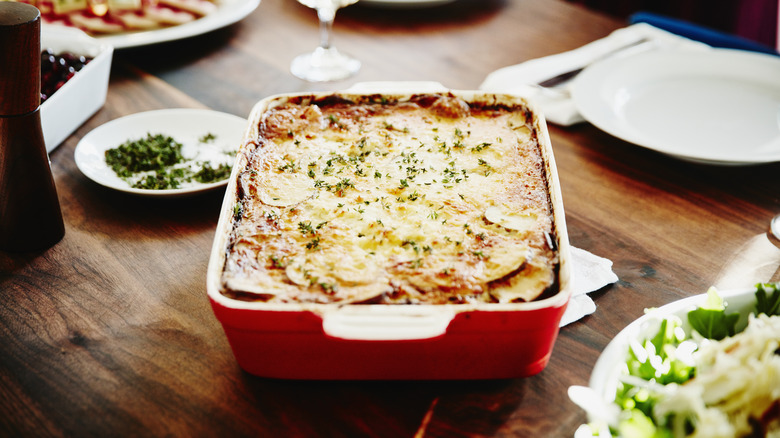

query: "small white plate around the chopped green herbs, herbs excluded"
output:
74 108 247 196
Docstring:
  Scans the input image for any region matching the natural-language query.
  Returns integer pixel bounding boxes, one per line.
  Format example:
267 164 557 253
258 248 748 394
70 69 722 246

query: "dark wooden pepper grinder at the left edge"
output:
0 1 65 251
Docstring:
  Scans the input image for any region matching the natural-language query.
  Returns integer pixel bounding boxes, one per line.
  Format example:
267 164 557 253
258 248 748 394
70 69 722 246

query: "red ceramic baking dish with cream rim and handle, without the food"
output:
207 87 570 380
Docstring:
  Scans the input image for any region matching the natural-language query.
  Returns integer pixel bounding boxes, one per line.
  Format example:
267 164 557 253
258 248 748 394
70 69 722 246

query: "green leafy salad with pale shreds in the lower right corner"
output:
577 284 780 438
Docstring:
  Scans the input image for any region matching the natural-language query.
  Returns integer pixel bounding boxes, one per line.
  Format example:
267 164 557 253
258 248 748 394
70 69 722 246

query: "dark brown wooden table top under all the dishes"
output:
0 0 780 437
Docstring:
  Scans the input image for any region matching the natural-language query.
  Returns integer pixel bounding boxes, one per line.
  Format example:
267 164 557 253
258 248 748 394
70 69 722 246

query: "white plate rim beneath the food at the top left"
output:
44 0 260 49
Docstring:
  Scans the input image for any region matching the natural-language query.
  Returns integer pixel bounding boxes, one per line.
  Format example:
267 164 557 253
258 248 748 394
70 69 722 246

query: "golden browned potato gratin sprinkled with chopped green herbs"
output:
222 94 559 304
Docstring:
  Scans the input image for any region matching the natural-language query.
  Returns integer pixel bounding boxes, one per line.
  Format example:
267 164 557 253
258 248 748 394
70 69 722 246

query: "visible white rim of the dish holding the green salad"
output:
589 288 756 418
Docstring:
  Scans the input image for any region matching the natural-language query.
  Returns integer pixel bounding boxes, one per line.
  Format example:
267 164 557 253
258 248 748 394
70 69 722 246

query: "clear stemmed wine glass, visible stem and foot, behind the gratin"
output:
290 0 360 82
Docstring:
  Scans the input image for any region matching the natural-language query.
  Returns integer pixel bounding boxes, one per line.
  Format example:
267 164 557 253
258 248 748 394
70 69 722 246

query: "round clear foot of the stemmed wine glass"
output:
290 47 360 82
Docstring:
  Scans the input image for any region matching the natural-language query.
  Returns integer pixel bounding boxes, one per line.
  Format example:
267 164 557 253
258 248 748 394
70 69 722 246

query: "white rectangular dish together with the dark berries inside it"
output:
41 25 114 152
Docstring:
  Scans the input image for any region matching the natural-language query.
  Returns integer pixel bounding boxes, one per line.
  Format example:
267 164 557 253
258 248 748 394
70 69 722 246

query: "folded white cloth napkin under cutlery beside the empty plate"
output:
479 23 709 126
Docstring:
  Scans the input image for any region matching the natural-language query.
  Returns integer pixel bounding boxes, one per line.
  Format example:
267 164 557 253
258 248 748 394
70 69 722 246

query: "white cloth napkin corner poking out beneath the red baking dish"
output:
560 247 618 327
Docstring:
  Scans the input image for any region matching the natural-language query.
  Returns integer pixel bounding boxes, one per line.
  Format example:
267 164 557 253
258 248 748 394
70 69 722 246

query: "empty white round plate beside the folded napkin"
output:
572 49 780 164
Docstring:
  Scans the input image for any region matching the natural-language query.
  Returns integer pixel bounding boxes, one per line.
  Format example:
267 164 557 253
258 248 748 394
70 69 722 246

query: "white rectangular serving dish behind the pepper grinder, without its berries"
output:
41 26 114 152
